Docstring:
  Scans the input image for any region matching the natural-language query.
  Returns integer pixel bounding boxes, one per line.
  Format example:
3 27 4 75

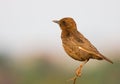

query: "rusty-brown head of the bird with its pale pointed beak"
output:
53 17 77 31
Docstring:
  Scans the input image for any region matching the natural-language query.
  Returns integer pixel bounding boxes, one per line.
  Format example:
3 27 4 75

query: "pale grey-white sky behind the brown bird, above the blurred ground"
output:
0 0 120 55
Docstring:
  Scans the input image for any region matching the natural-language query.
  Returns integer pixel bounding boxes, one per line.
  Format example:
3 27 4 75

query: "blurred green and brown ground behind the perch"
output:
0 54 120 84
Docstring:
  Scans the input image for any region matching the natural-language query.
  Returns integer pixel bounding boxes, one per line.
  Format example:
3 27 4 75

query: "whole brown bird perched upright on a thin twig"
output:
53 17 113 82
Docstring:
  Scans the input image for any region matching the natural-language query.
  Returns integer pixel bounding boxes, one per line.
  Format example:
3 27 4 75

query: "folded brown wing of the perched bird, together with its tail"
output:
71 32 112 63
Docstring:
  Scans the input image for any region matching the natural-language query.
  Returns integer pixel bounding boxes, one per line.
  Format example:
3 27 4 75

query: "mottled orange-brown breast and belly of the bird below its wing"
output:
62 38 89 61
